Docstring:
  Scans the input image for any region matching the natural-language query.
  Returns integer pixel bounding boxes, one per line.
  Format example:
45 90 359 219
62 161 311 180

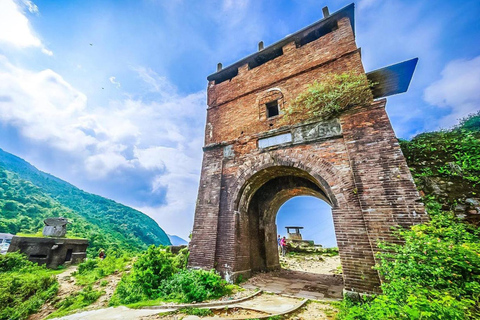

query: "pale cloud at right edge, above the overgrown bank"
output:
424 56 480 127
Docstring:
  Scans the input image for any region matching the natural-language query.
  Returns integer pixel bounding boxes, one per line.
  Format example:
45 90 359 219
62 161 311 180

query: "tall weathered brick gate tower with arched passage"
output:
189 4 427 293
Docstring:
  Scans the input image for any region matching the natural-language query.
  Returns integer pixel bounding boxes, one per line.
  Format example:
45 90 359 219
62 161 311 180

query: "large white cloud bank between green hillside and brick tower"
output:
0 56 205 236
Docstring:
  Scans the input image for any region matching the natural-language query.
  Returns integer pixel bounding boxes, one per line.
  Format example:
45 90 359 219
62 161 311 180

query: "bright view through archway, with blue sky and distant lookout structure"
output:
276 196 343 288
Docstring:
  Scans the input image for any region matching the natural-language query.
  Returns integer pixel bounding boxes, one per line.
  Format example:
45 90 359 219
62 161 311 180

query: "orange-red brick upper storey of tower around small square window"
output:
205 18 364 145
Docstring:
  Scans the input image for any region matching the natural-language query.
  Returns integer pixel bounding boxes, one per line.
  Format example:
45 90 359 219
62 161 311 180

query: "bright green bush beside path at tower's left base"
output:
110 246 231 305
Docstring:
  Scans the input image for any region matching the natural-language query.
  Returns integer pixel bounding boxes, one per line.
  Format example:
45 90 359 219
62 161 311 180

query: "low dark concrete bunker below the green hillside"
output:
8 236 88 269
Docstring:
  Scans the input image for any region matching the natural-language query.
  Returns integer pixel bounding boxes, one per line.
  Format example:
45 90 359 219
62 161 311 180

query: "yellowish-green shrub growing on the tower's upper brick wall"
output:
285 72 373 120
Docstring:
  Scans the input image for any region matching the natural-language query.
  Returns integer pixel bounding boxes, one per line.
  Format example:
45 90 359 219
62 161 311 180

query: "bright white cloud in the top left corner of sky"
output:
0 0 53 56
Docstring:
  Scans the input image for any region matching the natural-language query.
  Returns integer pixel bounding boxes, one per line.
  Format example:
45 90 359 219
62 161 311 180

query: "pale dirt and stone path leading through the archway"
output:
34 253 343 320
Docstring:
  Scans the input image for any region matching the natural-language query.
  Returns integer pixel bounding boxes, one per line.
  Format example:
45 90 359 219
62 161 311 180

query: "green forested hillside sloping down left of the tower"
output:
0 149 170 252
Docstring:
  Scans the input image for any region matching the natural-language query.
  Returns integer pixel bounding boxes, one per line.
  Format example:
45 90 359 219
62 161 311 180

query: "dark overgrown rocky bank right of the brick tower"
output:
400 112 480 225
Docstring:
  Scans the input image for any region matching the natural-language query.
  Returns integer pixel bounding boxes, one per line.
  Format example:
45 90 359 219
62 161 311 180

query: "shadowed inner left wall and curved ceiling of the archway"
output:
235 166 335 273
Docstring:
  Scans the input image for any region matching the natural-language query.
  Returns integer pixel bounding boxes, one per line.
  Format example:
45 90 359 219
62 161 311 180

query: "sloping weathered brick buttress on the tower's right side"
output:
341 99 426 250
